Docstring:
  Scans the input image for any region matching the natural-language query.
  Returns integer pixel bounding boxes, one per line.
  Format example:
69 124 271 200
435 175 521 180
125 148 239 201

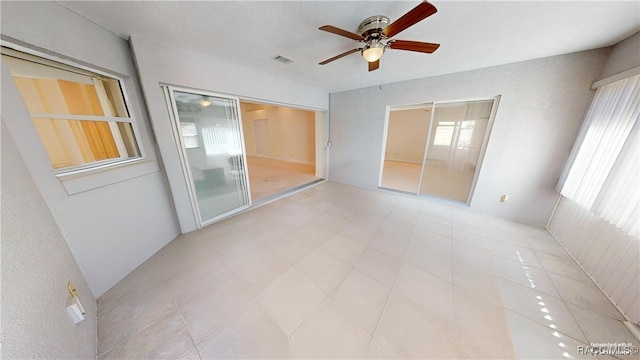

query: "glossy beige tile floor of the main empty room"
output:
98 182 638 359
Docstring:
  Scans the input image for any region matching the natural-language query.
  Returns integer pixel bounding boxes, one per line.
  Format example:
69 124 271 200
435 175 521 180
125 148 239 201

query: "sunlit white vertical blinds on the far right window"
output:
560 75 640 236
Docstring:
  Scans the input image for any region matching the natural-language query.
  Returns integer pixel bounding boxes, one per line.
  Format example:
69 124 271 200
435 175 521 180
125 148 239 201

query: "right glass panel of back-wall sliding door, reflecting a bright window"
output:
420 100 493 202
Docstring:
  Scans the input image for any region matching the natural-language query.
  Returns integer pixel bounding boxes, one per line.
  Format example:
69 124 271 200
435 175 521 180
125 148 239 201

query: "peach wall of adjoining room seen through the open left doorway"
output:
242 107 316 165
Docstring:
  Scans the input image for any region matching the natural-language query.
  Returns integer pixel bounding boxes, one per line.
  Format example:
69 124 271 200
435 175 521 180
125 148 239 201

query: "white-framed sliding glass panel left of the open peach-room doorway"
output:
165 87 251 226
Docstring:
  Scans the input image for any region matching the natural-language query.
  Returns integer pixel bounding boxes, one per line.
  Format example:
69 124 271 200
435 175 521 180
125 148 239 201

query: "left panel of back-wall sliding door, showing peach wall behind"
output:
380 104 432 193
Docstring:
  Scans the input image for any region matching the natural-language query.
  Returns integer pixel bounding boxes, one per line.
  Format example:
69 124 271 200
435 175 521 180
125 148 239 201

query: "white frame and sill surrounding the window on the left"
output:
0 38 161 197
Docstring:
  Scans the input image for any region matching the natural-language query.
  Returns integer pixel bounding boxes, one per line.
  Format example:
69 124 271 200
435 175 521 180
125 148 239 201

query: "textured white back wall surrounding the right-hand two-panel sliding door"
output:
330 49 609 226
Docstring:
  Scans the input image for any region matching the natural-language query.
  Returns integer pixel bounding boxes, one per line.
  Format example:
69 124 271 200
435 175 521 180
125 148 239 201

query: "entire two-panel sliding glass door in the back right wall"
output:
379 98 497 203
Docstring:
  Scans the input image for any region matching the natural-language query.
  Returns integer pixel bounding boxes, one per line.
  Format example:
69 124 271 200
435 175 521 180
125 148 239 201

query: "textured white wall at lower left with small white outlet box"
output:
0 122 97 359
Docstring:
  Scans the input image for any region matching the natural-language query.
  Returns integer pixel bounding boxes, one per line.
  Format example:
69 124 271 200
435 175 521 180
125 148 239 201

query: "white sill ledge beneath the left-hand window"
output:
56 158 160 195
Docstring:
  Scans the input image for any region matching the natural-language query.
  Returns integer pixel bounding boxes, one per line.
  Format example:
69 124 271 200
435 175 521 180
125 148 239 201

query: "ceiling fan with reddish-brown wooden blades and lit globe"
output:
320 0 440 71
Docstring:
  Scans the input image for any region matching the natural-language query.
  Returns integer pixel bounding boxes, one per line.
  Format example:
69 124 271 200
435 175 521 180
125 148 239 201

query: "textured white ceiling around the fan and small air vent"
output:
59 0 640 92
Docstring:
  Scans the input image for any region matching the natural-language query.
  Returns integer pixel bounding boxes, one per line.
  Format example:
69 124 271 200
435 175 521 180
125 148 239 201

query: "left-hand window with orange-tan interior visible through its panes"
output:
2 48 141 173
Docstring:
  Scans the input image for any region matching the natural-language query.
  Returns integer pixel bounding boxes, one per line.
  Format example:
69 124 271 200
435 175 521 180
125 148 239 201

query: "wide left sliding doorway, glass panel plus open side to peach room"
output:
163 85 327 228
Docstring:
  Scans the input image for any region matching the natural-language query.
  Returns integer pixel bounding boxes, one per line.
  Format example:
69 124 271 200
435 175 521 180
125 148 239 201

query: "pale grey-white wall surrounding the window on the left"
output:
1 2 179 297
